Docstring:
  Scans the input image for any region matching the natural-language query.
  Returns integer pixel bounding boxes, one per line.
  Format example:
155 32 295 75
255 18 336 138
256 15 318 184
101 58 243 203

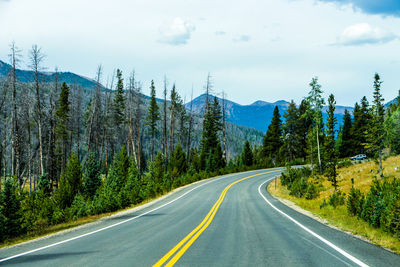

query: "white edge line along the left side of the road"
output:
0 171 262 263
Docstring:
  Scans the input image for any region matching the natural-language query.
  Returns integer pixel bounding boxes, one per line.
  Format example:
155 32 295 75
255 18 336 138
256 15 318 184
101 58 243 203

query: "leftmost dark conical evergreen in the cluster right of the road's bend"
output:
263 106 282 163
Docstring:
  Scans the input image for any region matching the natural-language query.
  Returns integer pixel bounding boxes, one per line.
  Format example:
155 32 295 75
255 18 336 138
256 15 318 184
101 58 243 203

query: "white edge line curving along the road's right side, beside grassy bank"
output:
258 177 368 267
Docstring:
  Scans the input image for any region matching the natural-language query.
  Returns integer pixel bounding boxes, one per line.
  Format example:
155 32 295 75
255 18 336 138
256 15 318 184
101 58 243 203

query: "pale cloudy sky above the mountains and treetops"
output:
0 0 400 105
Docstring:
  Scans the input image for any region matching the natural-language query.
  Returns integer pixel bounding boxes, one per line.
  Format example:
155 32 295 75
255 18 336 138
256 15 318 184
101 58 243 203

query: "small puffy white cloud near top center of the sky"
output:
159 17 196 45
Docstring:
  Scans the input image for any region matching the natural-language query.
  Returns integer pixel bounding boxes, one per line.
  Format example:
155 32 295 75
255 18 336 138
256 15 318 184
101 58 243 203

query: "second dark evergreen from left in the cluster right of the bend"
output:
283 100 300 162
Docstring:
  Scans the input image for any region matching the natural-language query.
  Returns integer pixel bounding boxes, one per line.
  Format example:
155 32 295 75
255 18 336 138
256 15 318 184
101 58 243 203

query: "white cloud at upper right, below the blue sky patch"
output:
336 23 398 46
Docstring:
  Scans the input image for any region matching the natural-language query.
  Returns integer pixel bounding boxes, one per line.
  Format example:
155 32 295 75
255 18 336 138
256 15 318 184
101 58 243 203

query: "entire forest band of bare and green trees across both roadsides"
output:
0 44 400 245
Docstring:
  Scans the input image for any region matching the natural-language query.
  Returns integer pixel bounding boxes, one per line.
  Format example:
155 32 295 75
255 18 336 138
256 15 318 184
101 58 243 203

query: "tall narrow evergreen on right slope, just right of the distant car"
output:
367 73 385 177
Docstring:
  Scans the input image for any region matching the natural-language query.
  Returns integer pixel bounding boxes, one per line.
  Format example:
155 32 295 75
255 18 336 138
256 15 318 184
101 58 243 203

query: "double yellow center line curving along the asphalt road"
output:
153 171 276 267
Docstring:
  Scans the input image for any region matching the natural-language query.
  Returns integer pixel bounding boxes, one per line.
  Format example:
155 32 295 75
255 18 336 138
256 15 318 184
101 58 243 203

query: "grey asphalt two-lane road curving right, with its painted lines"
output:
0 169 400 266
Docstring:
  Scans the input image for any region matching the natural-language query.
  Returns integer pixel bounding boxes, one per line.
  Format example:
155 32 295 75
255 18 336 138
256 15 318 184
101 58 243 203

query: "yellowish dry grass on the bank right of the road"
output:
268 156 400 253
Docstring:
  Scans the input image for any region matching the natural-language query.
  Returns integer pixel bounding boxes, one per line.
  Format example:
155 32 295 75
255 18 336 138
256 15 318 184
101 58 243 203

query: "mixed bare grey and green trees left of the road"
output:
0 43 245 241
